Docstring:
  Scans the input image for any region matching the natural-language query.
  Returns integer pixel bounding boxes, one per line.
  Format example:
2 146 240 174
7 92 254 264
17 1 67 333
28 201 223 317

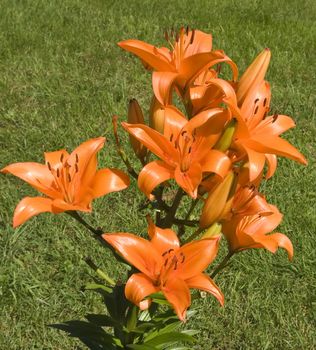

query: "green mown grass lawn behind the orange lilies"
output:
0 0 316 350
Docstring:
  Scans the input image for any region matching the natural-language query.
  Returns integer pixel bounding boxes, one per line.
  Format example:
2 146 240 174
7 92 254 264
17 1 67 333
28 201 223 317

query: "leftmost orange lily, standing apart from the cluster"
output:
1 137 129 227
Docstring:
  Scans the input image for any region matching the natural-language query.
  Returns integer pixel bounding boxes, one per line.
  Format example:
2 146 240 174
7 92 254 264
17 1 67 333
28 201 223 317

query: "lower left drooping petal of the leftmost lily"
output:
13 197 52 227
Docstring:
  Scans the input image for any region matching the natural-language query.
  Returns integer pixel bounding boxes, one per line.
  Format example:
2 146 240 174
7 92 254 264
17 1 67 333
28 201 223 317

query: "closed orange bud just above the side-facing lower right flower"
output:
200 171 235 229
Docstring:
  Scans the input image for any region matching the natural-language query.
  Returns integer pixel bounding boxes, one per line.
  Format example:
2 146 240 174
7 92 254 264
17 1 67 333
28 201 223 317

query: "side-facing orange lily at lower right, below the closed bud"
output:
222 205 293 260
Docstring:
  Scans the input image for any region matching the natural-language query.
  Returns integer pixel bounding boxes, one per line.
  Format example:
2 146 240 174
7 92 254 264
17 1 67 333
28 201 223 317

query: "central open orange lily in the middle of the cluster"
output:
122 106 231 200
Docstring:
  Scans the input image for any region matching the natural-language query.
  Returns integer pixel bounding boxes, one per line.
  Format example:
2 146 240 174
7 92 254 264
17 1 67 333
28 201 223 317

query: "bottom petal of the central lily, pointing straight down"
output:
174 163 202 198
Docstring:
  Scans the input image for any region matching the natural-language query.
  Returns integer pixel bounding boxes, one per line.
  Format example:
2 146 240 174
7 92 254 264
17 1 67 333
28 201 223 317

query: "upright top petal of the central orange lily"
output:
164 106 188 142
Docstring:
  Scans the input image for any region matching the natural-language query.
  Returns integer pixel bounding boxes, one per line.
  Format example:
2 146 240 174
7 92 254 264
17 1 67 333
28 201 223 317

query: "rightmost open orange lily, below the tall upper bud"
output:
232 81 307 182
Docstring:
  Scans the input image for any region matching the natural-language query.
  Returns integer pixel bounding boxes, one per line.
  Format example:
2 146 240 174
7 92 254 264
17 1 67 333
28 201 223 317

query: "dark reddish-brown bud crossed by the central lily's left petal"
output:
127 99 147 163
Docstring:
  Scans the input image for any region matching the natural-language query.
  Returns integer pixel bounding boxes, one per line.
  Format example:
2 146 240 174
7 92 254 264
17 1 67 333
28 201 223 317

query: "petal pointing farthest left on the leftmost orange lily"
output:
1 162 59 198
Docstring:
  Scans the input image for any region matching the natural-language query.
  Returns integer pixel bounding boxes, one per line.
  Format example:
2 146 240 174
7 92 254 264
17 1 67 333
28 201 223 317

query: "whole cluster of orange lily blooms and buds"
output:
1 28 306 320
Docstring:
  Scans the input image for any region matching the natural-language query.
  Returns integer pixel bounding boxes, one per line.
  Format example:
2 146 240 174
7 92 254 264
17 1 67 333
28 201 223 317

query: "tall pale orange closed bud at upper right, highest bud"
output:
237 48 271 106
